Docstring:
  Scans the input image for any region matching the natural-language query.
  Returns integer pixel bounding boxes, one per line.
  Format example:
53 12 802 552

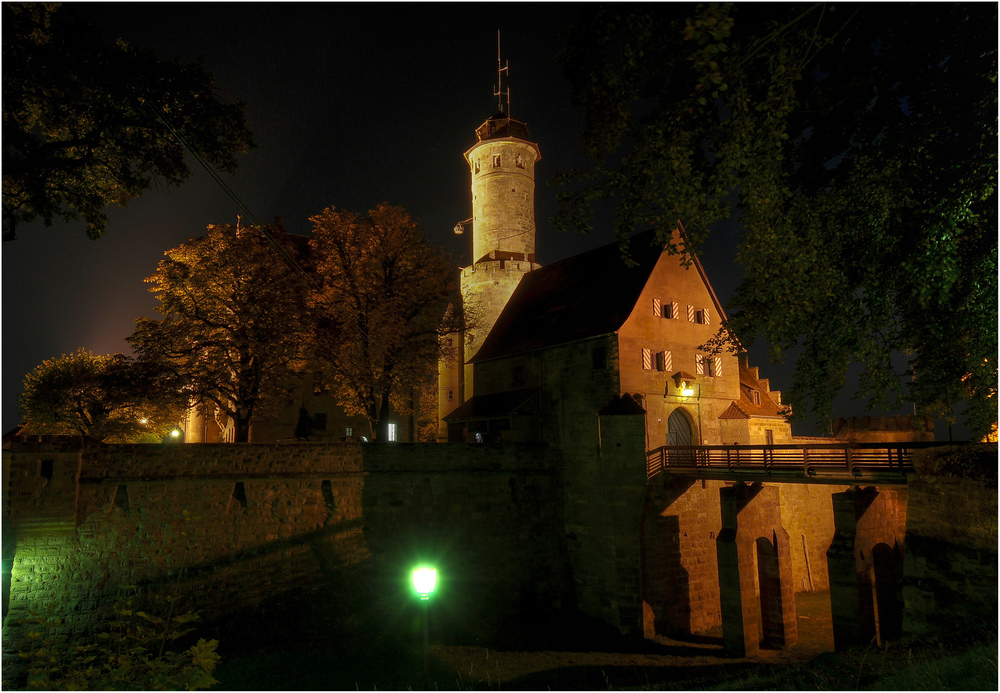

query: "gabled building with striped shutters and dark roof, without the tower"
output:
445 223 791 448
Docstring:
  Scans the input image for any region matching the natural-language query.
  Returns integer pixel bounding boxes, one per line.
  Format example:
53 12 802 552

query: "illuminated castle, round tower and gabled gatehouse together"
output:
438 104 791 448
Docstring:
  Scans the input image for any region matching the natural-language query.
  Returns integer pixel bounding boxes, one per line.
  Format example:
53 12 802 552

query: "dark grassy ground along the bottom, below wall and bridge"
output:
205 593 998 690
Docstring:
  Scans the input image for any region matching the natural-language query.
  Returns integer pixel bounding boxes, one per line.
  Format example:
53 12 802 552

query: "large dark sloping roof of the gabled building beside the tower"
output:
472 230 662 362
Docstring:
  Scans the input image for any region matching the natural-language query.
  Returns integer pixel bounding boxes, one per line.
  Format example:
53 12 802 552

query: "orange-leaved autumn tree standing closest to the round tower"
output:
310 203 455 440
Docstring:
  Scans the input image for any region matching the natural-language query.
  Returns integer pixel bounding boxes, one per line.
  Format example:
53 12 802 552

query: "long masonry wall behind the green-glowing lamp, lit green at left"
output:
4 439 572 668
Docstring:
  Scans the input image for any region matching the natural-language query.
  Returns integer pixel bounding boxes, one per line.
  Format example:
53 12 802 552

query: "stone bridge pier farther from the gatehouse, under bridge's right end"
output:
827 486 907 650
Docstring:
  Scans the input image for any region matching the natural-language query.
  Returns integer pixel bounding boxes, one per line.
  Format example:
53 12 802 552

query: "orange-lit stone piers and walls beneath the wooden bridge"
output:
640 474 907 656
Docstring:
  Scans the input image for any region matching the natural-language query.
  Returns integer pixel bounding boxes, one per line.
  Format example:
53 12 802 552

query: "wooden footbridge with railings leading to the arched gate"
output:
646 443 942 486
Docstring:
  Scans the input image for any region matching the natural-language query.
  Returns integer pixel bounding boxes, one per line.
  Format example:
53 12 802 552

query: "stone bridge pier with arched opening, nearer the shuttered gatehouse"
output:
716 483 798 657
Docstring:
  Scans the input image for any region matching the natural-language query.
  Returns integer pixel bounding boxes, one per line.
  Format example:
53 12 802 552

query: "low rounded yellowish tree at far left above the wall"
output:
20 349 183 443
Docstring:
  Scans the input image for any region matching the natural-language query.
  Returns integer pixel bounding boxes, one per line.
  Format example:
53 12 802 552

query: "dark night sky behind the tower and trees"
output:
3 3 920 438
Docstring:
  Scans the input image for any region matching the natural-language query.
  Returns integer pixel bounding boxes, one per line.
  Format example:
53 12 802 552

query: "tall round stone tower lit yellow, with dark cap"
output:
461 113 542 392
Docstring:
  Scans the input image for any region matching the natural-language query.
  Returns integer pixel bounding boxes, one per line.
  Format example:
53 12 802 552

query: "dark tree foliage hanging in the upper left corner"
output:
3 3 253 240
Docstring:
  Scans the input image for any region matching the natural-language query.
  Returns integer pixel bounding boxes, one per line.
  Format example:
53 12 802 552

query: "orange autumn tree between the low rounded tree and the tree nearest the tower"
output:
128 223 308 442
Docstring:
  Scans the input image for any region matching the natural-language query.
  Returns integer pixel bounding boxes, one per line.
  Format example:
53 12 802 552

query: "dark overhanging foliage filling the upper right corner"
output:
556 3 997 434
